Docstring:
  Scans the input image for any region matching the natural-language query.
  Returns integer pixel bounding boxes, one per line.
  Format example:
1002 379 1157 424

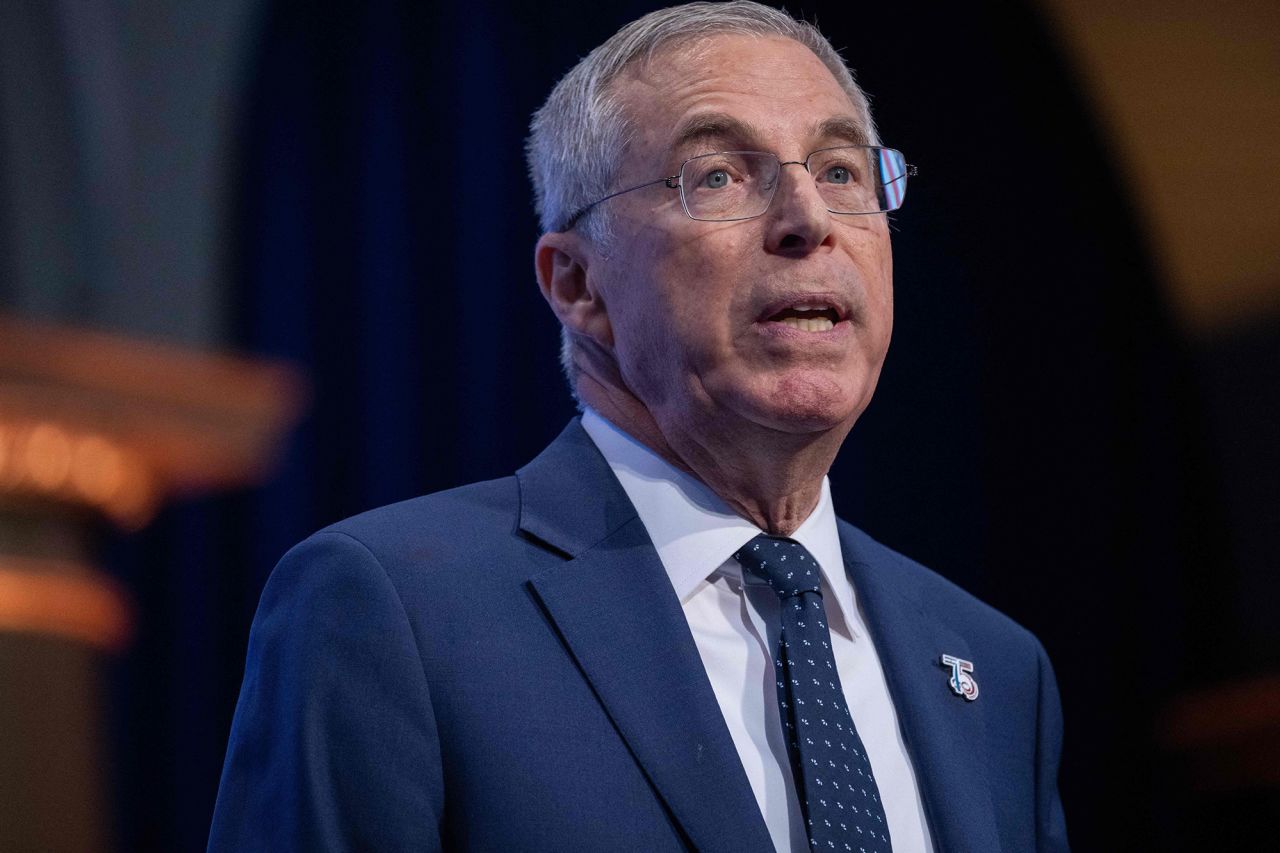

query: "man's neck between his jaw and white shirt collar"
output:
579 378 847 535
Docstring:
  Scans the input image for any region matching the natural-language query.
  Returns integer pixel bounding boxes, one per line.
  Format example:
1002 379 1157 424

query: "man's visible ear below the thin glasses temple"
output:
534 231 613 350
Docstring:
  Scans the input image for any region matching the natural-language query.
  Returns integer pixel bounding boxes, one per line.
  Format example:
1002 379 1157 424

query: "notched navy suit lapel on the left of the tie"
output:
517 421 772 852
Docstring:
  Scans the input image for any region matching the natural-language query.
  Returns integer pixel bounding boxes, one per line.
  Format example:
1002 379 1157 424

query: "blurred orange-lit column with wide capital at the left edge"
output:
0 315 305 852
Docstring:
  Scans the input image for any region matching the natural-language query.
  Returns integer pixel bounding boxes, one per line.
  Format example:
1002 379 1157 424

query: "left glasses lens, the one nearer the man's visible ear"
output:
680 151 778 222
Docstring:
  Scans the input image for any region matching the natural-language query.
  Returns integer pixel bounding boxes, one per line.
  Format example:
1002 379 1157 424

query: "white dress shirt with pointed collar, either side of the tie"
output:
582 409 933 853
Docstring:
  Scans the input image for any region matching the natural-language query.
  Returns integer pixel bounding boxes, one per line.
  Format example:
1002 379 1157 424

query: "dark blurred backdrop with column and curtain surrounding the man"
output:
0 0 1280 850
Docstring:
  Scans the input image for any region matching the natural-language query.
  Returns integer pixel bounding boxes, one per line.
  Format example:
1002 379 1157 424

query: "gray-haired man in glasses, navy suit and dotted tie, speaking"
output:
210 3 1066 852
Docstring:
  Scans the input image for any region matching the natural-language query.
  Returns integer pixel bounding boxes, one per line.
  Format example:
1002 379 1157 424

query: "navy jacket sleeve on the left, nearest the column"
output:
209 532 444 853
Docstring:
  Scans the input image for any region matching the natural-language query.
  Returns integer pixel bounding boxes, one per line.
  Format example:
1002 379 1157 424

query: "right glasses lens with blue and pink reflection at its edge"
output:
809 146 906 214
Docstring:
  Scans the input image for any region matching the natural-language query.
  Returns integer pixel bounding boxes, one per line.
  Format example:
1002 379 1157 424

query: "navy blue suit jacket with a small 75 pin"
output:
210 421 1066 853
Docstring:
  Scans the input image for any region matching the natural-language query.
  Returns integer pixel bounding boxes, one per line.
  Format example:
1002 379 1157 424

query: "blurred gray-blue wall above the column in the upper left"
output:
0 0 262 346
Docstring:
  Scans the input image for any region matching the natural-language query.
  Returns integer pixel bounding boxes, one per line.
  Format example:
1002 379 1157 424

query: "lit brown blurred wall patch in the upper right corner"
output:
1044 0 1280 339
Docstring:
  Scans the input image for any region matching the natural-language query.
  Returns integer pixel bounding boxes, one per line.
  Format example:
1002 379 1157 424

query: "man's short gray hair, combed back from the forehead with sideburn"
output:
525 0 878 397
